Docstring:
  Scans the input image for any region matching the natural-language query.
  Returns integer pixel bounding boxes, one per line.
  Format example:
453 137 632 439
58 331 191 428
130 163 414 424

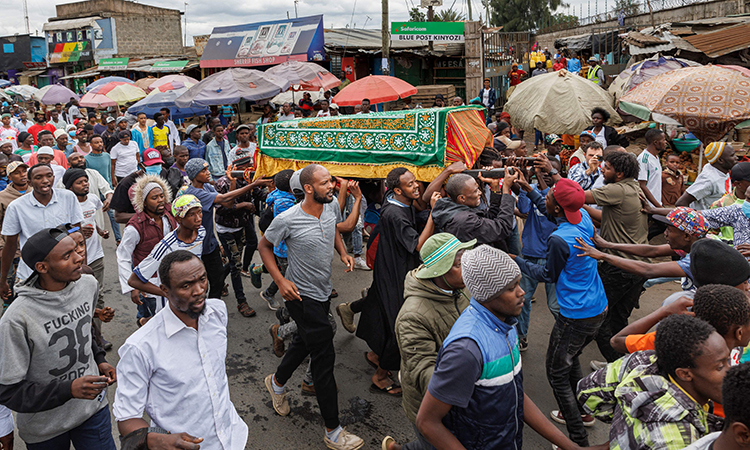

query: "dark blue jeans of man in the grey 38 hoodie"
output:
26 400 116 450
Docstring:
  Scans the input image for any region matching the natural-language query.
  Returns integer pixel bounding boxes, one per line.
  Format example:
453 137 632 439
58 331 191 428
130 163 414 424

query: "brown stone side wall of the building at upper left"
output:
115 15 184 57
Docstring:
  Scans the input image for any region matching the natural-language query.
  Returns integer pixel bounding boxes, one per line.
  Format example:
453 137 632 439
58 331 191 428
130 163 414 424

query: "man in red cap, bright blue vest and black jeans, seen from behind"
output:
515 178 607 446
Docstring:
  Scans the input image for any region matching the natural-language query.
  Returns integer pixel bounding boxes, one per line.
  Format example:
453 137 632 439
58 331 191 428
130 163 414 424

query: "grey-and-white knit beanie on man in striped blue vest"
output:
461 245 521 303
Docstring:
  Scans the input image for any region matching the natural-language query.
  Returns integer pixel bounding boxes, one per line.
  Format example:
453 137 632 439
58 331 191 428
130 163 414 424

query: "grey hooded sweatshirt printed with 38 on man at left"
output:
0 275 107 444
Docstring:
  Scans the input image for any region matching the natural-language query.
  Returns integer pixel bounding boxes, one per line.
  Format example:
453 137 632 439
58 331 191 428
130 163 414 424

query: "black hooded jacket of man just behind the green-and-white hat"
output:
432 192 516 249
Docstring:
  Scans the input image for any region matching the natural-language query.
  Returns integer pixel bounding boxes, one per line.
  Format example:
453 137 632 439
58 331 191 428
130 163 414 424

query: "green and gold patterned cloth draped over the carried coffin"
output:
255 106 492 181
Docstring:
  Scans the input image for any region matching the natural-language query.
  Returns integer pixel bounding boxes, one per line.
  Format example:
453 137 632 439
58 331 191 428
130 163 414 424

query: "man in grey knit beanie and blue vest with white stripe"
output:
417 245 596 450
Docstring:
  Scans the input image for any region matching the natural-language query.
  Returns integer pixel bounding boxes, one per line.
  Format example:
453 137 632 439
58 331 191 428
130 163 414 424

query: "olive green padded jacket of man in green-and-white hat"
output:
396 269 469 423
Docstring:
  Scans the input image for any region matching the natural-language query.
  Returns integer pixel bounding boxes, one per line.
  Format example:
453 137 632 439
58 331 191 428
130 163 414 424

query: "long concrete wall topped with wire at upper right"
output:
535 0 750 49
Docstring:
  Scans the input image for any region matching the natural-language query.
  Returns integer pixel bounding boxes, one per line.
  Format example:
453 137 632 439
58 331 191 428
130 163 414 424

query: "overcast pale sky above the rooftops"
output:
0 0 596 45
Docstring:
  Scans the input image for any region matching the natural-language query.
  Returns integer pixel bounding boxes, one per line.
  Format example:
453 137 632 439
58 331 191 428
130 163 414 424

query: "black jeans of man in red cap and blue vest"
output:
546 310 607 447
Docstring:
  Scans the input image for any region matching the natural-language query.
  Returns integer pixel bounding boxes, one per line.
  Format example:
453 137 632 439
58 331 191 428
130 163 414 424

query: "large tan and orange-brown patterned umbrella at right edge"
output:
620 65 750 142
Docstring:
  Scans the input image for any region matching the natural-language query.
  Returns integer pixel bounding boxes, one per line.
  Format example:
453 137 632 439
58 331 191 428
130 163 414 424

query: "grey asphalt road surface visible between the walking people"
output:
10 230 679 450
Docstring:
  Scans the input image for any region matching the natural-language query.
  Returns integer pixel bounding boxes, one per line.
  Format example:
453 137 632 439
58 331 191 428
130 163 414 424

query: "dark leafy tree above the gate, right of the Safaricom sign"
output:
490 0 564 31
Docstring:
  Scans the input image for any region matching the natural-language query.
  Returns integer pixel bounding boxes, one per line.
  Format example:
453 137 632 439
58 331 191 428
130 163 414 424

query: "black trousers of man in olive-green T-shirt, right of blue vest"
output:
596 263 646 362
